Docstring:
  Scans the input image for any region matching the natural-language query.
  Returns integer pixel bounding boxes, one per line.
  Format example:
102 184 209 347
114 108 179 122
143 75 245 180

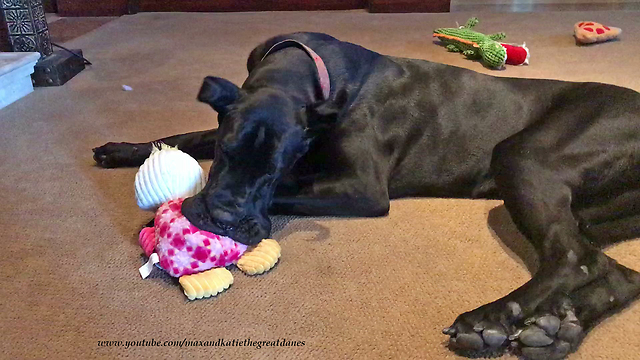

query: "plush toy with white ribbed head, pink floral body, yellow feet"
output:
135 144 281 300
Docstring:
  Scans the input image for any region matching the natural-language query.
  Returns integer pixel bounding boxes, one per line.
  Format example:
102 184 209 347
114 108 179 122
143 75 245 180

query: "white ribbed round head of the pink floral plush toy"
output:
135 143 206 211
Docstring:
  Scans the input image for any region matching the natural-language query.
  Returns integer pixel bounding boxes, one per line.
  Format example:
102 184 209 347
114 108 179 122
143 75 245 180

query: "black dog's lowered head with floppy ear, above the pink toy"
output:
182 77 320 245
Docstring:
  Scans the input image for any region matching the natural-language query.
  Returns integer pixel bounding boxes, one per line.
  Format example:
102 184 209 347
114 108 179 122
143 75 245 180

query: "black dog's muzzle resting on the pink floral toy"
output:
182 195 271 246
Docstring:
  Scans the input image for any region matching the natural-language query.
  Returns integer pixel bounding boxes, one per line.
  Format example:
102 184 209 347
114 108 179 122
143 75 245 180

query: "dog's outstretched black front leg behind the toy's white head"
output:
93 129 216 168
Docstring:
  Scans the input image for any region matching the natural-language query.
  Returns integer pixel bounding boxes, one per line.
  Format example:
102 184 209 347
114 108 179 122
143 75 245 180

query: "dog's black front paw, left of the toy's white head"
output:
93 142 151 168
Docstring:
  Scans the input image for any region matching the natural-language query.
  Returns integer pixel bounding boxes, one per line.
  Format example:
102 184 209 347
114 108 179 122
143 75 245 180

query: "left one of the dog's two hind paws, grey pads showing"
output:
443 302 523 358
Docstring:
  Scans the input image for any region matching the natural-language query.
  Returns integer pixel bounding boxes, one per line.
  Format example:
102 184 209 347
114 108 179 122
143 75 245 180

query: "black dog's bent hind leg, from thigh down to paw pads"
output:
445 86 640 359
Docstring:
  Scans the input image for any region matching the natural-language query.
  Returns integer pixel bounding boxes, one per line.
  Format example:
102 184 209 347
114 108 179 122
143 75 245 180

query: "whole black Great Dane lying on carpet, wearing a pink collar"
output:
94 33 640 359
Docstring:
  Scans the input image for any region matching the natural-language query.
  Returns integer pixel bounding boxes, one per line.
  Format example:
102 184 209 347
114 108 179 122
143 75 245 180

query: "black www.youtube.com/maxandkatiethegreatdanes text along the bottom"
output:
98 338 304 349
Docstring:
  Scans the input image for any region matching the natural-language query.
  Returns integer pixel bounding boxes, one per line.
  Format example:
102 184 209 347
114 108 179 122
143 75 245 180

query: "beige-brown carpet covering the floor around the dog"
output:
0 11 640 360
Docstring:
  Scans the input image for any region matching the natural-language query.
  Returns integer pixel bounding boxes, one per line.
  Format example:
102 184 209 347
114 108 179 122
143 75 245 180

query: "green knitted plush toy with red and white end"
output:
433 17 529 69
